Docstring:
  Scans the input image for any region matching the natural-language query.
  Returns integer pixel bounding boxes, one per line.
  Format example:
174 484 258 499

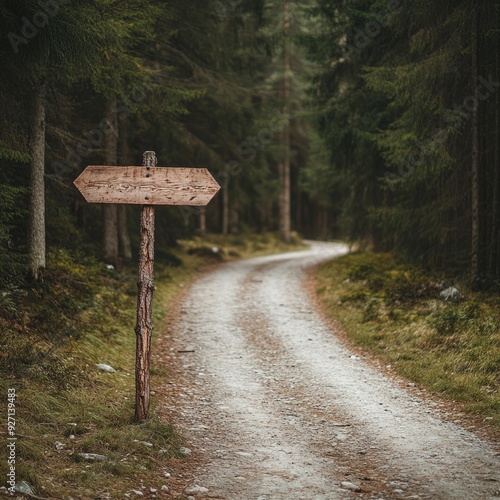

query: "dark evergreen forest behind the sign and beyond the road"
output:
0 0 500 289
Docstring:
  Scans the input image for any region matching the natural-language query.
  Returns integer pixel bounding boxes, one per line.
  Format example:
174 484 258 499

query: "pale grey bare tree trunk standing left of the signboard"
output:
30 83 46 279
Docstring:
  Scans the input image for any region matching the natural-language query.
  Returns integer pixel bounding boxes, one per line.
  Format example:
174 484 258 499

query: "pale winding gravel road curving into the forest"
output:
161 243 500 500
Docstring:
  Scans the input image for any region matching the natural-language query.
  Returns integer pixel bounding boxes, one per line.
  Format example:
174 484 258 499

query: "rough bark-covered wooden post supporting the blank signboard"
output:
135 151 156 422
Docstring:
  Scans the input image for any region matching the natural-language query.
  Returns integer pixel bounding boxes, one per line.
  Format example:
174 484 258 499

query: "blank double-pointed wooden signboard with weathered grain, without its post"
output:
74 165 220 206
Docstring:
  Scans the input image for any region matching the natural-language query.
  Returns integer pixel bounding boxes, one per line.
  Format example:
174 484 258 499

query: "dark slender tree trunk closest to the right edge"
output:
470 0 481 286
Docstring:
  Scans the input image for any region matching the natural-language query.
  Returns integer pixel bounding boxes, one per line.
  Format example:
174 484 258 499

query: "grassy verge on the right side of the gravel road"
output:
316 253 500 433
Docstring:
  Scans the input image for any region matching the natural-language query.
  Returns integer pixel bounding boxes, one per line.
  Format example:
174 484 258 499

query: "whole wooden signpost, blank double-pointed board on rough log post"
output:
74 151 220 421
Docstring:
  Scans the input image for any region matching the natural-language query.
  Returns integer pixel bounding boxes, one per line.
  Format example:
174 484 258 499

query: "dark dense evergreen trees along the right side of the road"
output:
305 0 500 286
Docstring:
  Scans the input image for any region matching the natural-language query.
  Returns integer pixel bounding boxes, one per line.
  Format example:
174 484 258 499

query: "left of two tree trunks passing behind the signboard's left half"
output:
102 100 119 266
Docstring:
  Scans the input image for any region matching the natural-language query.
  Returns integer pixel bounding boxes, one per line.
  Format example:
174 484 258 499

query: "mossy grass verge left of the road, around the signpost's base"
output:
0 235 297 499
